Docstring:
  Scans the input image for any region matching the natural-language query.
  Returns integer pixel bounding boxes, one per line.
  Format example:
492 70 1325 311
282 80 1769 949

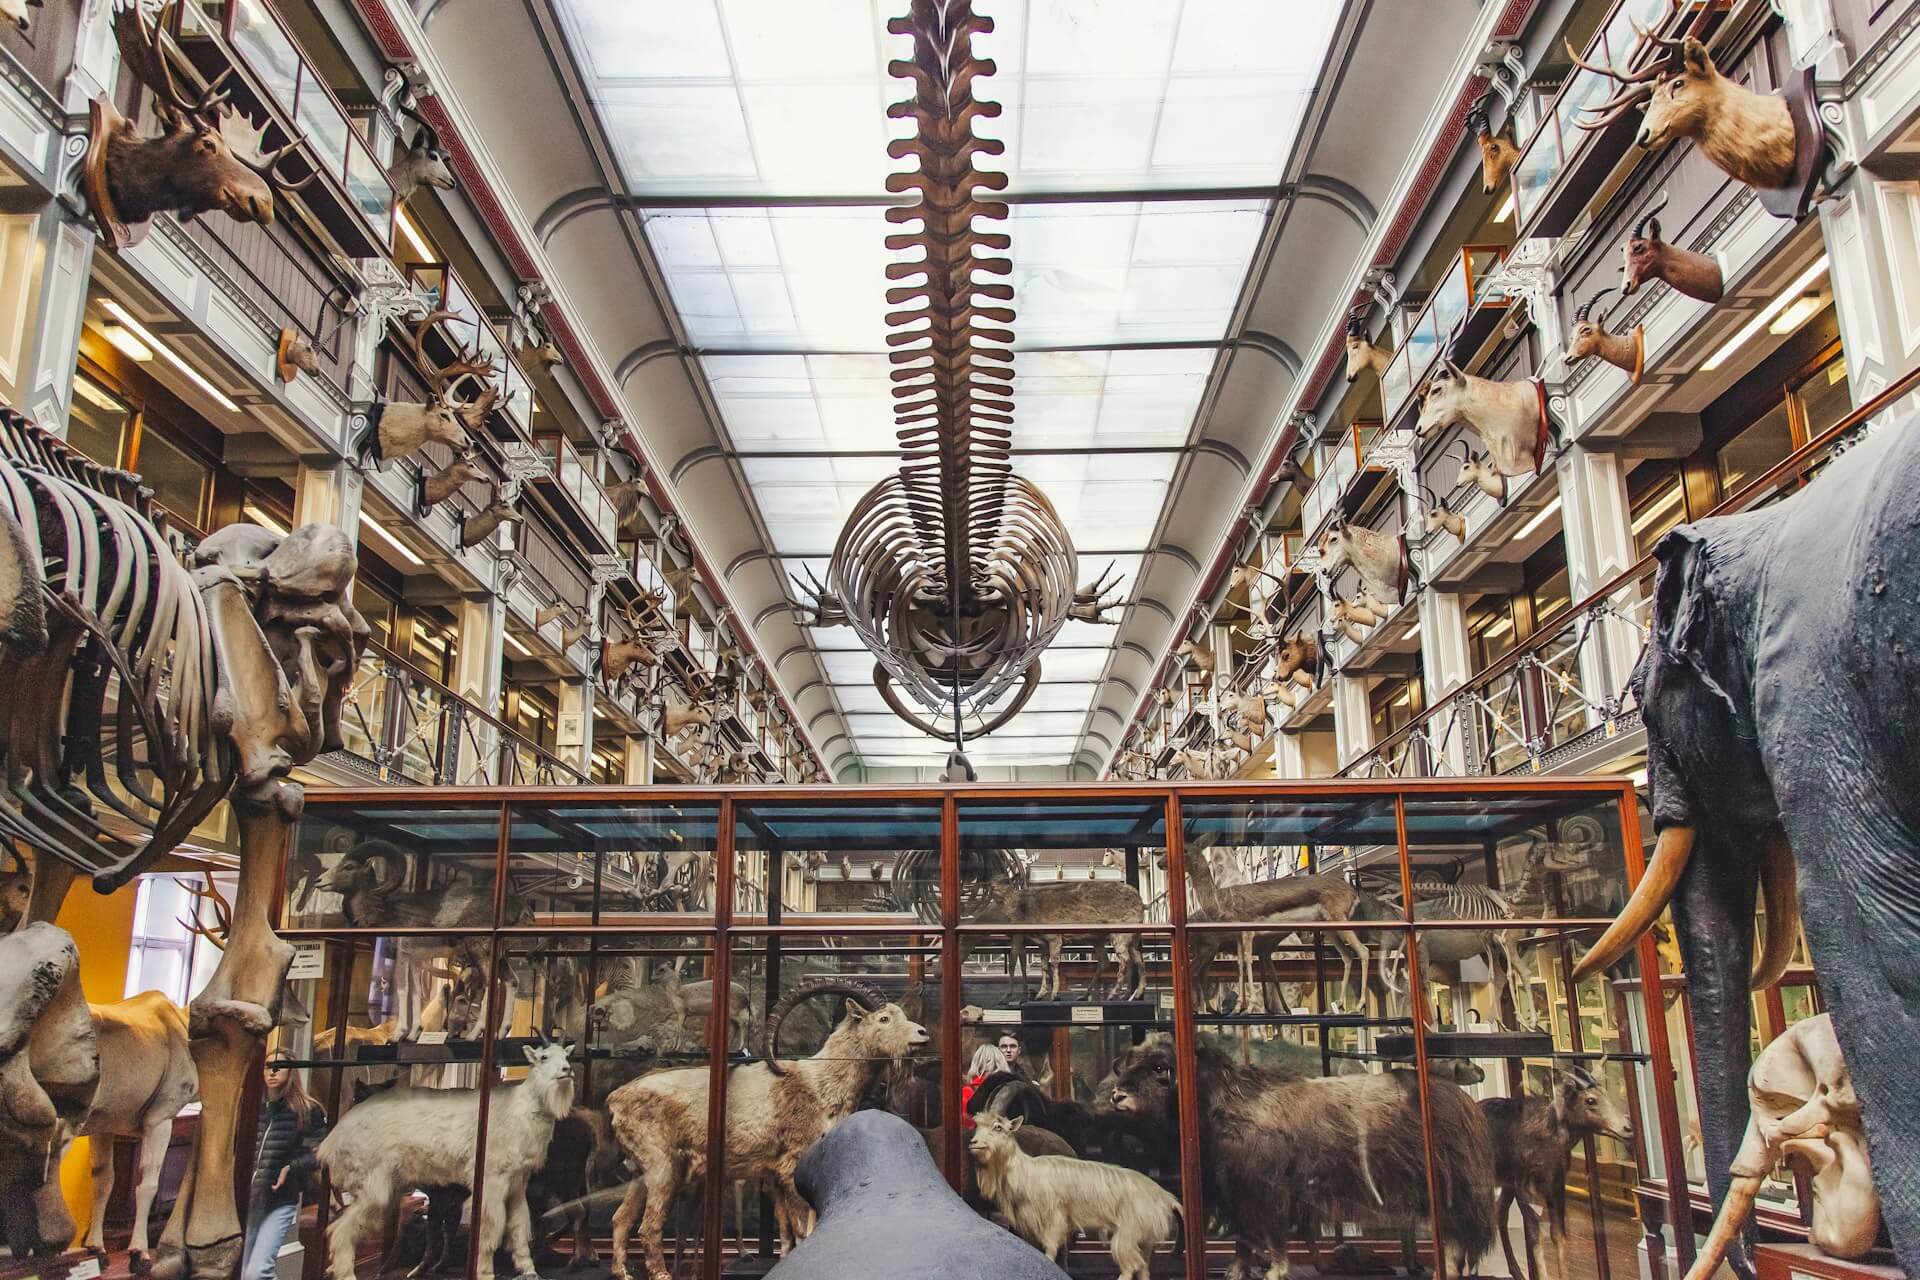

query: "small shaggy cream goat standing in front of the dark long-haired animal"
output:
968 1115 1181 1280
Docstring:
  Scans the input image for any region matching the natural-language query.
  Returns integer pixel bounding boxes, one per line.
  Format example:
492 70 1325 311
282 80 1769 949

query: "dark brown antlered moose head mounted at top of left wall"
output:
81 0 319 251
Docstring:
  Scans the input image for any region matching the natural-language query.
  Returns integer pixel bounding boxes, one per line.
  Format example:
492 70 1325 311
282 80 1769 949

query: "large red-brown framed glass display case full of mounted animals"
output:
280 777 1697 1276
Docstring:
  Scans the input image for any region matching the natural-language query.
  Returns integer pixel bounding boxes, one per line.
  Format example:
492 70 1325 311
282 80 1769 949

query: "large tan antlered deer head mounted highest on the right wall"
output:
1567 18 1797 188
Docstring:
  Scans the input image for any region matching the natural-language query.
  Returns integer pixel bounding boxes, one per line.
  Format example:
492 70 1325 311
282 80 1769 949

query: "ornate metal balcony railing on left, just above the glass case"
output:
332 643 586 787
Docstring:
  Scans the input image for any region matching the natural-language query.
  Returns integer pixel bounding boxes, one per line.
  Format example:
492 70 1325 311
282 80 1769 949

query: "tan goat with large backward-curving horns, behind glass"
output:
602 979 927 1280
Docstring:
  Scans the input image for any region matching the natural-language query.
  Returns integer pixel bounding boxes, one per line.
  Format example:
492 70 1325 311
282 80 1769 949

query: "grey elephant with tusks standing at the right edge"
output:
1574 415 1920 1276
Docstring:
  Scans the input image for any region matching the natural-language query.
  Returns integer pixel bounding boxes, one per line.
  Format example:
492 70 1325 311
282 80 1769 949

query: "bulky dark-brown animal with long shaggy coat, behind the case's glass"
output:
1114 1038 1494 1280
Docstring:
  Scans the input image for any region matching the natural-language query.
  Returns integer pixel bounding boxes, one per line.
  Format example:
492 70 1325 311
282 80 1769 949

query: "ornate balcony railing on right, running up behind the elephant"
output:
1340 368 1920 777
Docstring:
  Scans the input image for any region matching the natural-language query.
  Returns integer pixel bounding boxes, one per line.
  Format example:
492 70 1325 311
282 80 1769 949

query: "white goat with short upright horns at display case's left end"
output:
317 1044 574 1280
